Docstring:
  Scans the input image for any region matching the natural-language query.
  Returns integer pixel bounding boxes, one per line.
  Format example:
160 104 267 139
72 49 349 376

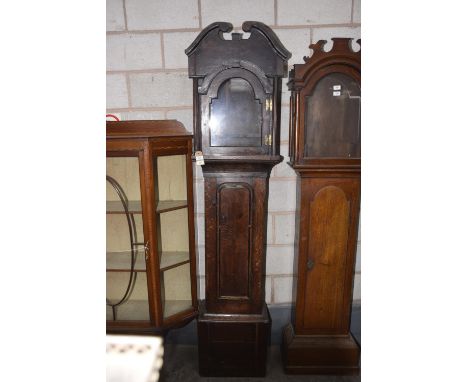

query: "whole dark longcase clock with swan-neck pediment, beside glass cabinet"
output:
185 21 291 376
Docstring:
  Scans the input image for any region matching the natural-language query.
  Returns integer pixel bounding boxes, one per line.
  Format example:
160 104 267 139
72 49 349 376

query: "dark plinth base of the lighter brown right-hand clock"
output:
282 324 361 375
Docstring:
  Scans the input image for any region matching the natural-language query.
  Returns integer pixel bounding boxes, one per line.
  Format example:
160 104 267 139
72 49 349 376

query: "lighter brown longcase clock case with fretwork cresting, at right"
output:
283 38 361 374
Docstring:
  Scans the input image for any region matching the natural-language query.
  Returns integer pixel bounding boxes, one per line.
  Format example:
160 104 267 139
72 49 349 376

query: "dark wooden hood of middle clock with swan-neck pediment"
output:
185 22 291 160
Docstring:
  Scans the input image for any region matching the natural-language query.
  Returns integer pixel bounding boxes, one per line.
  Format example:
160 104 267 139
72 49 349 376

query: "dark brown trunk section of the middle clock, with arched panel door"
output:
203 164 269 314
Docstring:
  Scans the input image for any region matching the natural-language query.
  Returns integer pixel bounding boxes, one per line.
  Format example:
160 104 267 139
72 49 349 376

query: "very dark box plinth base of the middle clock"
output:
198 303 271 377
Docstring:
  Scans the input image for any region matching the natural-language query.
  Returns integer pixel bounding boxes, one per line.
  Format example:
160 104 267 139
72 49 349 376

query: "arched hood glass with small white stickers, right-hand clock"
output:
304 73 361 158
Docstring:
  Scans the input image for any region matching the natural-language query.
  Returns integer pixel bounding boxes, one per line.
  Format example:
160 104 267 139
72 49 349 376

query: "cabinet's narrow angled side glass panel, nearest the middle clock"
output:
154 154 192 320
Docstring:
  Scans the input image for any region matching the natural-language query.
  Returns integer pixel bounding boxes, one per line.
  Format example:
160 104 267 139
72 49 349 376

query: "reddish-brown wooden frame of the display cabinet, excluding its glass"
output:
106 120 198 333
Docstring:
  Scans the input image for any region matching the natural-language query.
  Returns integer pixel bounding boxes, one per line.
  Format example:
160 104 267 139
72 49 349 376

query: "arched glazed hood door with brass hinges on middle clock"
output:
201 68 272 156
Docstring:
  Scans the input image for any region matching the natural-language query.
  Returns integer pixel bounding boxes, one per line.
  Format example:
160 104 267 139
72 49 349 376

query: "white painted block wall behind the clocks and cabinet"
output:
107 0 361 305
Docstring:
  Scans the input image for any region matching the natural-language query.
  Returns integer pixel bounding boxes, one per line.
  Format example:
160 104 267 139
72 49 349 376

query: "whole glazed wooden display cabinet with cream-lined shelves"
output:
106 121 198 333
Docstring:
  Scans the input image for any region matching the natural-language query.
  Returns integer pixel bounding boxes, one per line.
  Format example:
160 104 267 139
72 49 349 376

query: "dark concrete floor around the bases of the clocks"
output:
160 344 361 382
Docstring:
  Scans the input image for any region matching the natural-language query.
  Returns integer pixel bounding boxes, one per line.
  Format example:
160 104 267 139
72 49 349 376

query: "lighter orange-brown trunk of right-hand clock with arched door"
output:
297 178 359 334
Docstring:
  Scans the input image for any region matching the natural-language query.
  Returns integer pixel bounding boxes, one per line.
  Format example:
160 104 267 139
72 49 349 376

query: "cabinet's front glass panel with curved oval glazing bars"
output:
106 156 150 321
